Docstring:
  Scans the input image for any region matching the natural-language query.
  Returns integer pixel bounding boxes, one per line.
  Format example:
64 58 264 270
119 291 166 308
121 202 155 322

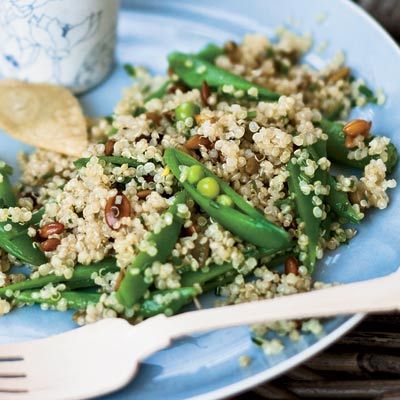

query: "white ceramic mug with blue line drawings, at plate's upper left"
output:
0 0 119 93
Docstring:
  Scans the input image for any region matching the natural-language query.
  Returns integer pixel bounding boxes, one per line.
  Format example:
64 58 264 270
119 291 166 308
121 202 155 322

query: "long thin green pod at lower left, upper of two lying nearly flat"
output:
0 257 119 297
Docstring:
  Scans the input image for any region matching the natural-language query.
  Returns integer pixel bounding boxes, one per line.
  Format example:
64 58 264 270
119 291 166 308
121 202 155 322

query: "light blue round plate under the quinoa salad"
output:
0 0 400 400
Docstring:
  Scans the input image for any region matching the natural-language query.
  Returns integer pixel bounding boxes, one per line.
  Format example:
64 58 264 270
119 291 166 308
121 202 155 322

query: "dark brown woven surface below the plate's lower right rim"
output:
238 314 400 400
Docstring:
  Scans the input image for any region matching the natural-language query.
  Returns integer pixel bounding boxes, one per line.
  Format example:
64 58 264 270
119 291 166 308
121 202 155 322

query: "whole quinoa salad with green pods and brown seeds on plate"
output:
0 31 397 354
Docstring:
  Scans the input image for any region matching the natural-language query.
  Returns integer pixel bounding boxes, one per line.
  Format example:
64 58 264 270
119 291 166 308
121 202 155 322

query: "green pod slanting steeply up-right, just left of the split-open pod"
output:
117 192 186 307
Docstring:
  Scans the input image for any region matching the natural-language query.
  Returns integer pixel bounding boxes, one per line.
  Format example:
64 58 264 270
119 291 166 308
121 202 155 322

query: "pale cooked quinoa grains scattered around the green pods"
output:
0 30 396 350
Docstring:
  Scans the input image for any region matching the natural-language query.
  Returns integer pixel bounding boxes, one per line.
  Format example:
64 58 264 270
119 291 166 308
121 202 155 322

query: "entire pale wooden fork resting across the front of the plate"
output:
0 272 400 400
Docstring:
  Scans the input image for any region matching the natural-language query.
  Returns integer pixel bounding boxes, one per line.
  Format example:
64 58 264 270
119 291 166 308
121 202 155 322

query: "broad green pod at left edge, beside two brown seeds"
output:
0 221 47 265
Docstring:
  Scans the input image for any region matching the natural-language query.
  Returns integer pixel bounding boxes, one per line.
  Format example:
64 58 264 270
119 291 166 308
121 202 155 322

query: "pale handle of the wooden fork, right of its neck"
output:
167 270 400 338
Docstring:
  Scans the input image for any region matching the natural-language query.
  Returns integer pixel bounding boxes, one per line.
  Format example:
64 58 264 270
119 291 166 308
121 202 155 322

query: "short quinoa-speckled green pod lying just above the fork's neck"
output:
138 287 199 318
